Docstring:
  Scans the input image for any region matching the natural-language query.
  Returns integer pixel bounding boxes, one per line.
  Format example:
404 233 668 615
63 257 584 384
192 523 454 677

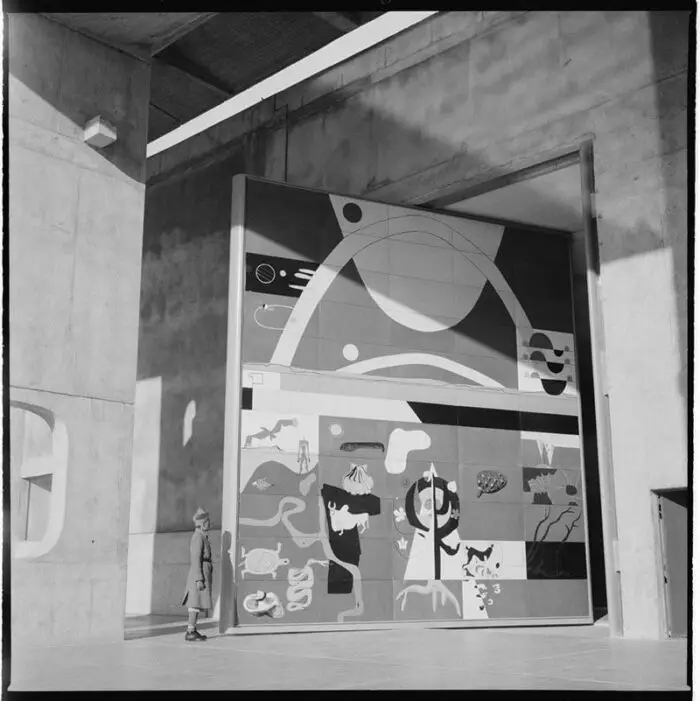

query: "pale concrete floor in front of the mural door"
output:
10 617 689 691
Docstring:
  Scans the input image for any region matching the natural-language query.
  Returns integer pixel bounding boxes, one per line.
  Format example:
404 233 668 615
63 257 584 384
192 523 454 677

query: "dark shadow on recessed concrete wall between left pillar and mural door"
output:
138 157 245 532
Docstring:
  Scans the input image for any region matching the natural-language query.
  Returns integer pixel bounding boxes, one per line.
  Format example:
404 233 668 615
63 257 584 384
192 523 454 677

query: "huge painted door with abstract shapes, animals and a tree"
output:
226 176 592 626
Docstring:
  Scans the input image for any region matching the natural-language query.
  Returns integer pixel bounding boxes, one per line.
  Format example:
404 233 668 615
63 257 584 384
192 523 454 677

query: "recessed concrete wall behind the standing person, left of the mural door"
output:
135 145 264 614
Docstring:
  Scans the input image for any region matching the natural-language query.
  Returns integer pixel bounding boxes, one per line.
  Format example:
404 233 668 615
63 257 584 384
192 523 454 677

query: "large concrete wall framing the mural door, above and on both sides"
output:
137 12 689 637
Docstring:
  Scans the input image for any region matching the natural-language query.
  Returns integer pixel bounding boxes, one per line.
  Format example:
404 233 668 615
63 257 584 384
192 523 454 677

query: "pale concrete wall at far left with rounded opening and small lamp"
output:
7 14 150 644
